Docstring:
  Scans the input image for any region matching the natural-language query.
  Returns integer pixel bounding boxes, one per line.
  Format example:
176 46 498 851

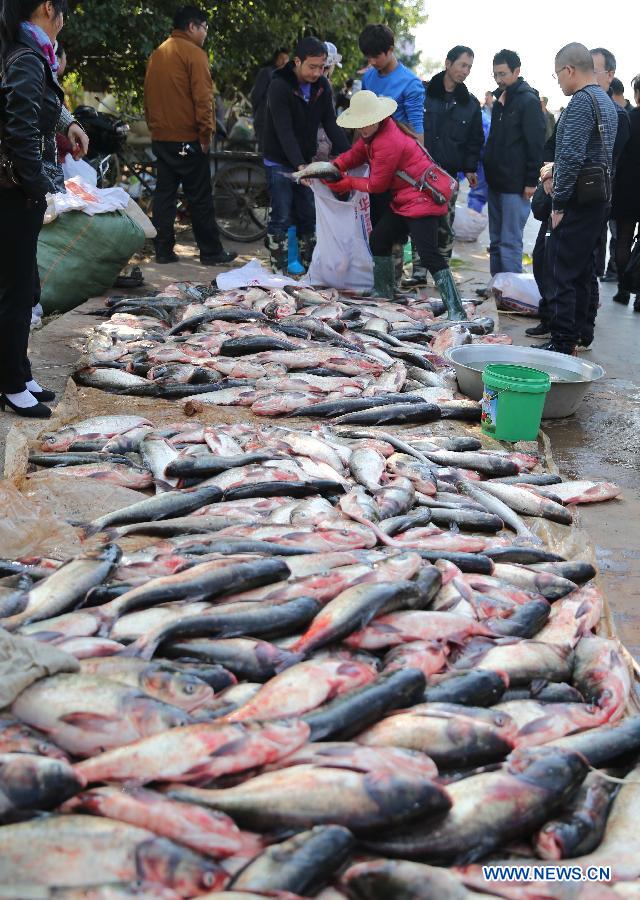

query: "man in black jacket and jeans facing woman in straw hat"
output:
264 37 349 273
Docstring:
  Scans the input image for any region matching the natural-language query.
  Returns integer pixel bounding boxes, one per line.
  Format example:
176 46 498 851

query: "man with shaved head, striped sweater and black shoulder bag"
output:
538 43 618 355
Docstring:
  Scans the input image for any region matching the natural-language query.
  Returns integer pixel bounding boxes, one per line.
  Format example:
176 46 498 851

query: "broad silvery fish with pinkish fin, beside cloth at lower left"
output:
11 674 190 756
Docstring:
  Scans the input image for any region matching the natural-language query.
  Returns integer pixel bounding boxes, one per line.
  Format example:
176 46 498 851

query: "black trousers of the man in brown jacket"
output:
151 141 223 256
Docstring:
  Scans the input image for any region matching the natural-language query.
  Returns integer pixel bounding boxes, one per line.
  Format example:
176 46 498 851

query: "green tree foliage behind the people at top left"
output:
61 0 423 105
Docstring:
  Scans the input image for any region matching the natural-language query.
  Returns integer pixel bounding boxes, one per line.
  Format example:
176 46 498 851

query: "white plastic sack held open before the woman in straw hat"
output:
308 180 373 291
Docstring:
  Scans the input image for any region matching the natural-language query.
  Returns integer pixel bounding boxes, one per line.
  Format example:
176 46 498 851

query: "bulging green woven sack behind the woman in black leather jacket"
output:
38 210 145 314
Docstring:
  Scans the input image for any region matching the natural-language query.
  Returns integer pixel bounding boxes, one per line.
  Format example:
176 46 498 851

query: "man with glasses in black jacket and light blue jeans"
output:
484 50 545 275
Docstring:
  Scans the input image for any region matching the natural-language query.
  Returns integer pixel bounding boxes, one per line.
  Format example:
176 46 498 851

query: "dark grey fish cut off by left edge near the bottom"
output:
0 753 85 821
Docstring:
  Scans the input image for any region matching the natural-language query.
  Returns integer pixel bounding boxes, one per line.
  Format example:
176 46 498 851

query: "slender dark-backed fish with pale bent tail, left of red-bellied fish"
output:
125 597 320 659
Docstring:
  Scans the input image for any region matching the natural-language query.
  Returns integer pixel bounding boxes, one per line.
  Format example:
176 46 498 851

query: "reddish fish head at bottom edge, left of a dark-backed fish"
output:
136 838 229 897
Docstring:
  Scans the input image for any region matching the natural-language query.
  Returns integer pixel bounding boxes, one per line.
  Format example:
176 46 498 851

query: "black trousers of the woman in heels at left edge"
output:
0 190 47 394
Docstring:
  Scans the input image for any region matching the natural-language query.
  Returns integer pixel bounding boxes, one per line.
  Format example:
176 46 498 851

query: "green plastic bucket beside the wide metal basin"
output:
481 365 551 441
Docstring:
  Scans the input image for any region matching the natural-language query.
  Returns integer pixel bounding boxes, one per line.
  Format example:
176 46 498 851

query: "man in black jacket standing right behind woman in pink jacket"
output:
424 46 484 259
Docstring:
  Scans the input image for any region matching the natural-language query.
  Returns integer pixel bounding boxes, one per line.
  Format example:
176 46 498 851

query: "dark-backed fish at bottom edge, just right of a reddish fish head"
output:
229 825 354 896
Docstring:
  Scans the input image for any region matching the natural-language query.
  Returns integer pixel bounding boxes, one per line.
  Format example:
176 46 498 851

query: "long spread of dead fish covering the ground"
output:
0 284 640 900
